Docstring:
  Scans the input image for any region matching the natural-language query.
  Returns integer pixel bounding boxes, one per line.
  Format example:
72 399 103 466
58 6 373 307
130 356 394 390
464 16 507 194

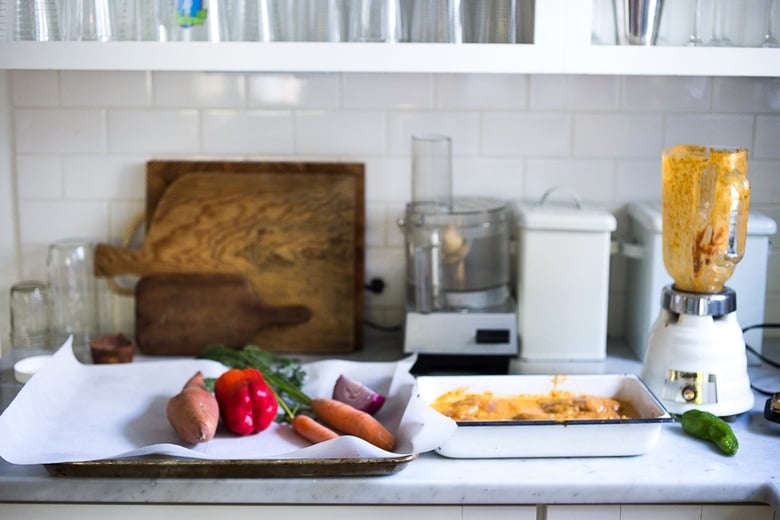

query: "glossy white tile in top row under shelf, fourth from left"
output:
247 74 341 109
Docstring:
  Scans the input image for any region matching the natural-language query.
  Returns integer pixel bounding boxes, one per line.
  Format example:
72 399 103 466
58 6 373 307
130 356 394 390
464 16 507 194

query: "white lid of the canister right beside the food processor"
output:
515 202 617 232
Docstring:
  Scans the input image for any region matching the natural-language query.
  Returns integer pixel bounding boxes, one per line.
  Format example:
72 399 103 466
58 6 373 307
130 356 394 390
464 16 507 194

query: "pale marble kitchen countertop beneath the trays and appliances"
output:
0 333 780 511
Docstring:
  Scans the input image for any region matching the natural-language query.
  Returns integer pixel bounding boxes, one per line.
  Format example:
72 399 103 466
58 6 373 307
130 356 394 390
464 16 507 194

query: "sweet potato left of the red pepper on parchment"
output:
165 372 219 444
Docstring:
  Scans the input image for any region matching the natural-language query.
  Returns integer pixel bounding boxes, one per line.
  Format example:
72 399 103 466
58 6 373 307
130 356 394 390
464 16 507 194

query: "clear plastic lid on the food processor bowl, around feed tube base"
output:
405 197 509 227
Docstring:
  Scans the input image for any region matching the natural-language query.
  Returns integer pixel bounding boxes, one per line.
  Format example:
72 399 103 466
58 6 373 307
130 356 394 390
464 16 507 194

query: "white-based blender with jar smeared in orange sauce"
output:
641 145 753 417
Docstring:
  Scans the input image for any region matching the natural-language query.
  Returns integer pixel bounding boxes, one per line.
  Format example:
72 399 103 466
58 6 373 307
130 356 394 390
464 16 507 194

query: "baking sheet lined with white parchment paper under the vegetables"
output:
0 342 455 478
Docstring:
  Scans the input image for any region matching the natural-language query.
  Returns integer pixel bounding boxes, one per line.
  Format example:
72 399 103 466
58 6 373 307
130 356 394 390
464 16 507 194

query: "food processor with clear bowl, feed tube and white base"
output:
399 135 517 373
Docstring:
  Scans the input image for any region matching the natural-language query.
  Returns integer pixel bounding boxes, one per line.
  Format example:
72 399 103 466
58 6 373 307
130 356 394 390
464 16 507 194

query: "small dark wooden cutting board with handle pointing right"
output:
135 273 312 356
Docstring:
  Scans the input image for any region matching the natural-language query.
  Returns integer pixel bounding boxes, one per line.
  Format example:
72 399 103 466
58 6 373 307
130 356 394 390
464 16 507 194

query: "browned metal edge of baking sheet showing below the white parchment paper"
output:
44 454 417 478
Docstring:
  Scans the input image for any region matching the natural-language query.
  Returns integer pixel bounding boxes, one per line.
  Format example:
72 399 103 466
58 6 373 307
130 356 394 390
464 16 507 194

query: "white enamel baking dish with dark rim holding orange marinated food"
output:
417 374 674 458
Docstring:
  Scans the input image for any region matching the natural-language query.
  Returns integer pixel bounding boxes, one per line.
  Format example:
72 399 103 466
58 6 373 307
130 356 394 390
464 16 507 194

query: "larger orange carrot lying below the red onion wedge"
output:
311 398 395 451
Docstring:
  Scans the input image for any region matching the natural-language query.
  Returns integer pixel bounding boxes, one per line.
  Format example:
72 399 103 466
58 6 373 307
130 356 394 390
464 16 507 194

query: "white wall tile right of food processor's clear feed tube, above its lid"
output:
452 157 525 200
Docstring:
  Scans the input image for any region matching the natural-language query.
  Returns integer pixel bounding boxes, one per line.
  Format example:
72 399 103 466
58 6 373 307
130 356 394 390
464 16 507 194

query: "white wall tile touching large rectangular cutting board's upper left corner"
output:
62 155 146 200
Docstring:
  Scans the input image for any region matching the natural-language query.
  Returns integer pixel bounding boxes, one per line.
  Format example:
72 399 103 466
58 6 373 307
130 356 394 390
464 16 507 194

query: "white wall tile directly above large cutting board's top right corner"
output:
293 111 386 155
